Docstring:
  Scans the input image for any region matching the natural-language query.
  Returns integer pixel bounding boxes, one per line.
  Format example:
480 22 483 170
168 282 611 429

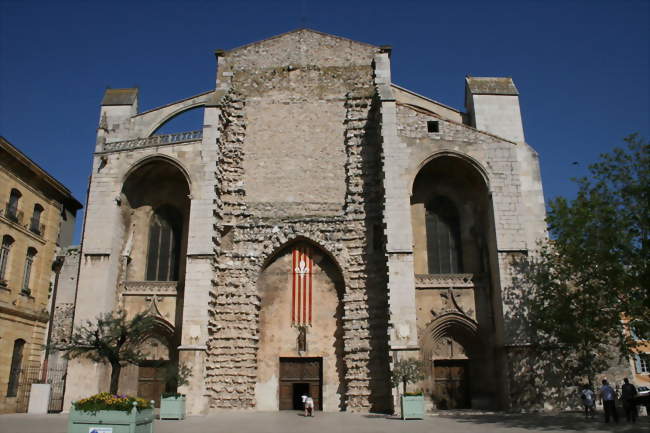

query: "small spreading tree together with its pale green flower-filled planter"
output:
50 311 154 433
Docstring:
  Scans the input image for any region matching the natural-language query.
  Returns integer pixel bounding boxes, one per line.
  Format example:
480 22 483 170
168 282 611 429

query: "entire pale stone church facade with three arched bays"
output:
66 30 545 413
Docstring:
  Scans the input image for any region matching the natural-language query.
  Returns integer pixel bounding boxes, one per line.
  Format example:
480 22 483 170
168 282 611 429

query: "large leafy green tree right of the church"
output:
511 134 650 383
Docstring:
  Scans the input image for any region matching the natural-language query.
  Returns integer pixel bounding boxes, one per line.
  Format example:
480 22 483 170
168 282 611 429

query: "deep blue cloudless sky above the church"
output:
0 0 650 239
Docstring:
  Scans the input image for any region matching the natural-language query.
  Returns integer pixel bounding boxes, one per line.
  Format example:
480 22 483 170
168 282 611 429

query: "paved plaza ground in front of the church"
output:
0 411 650 433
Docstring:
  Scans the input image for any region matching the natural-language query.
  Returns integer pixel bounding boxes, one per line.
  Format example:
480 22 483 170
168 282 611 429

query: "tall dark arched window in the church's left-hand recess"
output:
145 206 182 281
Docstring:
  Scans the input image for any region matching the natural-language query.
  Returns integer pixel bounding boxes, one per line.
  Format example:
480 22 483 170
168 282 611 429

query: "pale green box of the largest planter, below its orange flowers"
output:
68 407 154 433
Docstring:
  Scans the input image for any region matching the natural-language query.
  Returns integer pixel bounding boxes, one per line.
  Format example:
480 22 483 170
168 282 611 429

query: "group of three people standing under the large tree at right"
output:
580 378 637 422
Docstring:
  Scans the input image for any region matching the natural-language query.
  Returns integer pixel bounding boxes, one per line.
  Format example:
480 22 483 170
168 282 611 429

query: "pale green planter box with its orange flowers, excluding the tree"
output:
68 392 154 433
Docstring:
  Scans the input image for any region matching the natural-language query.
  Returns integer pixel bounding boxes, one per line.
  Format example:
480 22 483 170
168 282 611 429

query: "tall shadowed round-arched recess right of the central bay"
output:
411 152 496 408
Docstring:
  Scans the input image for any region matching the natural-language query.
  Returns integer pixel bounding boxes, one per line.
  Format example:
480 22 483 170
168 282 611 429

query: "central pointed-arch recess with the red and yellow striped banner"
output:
255 238 347 411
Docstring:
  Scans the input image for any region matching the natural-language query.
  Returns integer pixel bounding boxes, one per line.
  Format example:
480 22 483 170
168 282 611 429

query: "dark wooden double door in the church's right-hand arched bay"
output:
433 360 470 409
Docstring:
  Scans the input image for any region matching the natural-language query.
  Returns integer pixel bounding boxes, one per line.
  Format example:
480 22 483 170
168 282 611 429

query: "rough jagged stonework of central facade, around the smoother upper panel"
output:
206 32 390 410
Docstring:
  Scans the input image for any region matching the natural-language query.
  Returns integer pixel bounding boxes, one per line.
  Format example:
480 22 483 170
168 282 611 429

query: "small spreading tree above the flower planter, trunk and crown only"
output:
51 311 153 394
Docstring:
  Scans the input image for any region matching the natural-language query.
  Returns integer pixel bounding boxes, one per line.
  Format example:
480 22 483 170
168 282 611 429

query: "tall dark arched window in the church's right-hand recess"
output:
426 196 463 274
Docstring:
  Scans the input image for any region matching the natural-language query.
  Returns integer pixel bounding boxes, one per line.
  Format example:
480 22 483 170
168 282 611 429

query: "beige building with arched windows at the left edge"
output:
0 137 81 413
